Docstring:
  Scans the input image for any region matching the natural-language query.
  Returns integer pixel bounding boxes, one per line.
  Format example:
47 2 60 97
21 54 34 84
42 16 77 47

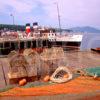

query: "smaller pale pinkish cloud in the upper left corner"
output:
0 0 36 13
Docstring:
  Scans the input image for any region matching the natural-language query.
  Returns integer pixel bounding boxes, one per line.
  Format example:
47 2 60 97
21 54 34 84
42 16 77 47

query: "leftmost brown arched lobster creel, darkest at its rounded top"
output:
8 54 29 78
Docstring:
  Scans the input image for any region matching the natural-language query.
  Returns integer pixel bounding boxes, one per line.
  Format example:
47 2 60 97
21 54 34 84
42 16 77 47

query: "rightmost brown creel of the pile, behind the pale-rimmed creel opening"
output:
40 47 66 75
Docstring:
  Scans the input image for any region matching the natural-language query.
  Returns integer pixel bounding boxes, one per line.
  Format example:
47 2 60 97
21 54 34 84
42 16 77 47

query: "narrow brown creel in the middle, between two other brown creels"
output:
24 49 41 77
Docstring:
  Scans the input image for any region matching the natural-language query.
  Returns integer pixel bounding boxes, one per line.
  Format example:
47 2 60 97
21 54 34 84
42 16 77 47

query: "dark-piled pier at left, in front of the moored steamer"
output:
0 39 48 55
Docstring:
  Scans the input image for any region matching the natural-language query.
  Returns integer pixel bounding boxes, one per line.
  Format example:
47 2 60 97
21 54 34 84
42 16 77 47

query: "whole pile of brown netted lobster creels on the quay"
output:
8 47 66 83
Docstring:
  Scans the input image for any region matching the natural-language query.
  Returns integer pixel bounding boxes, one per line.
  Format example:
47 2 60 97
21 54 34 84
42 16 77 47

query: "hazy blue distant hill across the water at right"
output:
70 26 100 33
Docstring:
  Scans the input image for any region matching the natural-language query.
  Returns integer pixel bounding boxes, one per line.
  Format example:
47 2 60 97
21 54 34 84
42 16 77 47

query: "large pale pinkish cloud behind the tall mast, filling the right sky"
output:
38 0 100 27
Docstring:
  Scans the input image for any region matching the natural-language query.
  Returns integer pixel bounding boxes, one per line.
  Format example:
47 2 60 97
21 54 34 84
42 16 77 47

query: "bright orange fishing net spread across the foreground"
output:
0 76 100 96
